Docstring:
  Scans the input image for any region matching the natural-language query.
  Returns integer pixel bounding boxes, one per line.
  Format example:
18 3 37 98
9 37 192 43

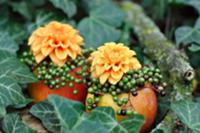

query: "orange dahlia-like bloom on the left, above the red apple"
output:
28 21 83 66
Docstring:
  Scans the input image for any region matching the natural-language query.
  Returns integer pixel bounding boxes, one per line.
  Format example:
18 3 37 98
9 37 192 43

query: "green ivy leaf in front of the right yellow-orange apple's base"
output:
89 107 144 133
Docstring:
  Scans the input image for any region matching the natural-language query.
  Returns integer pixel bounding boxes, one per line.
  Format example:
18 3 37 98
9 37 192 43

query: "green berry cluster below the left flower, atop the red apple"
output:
21 49 91 94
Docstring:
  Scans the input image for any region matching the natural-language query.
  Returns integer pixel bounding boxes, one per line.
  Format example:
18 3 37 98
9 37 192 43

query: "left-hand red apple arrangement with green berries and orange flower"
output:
21 21 88 102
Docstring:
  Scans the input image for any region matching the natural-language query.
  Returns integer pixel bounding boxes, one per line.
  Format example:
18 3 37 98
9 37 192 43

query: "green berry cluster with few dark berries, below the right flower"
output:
87 66 167 109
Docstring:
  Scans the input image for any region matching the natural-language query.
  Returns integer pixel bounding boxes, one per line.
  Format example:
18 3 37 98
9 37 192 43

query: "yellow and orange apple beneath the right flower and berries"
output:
86 83 157 133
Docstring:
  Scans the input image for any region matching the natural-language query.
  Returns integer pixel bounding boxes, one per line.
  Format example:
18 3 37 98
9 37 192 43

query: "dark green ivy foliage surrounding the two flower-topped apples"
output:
0 0 200 133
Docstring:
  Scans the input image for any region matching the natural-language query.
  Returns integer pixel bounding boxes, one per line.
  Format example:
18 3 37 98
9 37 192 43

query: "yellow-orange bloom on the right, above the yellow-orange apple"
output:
89 42 141 84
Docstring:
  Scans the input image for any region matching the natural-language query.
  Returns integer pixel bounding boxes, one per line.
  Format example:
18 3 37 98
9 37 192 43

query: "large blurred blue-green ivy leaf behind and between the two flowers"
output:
78 2 124 48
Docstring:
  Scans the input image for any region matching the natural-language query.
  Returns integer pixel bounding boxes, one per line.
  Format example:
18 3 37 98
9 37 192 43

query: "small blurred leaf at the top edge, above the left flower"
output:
50 0 77 17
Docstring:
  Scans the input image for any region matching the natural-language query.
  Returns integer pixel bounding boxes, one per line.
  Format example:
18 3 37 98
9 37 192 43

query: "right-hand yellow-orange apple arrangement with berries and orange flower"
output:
86 42 166 133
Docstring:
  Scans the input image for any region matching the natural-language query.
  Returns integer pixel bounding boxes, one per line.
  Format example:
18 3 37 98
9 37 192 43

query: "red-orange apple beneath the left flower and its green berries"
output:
28 68 87 103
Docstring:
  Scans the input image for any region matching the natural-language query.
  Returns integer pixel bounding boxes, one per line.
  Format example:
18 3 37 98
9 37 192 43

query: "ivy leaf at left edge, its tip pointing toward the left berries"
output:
0 51 37 84
